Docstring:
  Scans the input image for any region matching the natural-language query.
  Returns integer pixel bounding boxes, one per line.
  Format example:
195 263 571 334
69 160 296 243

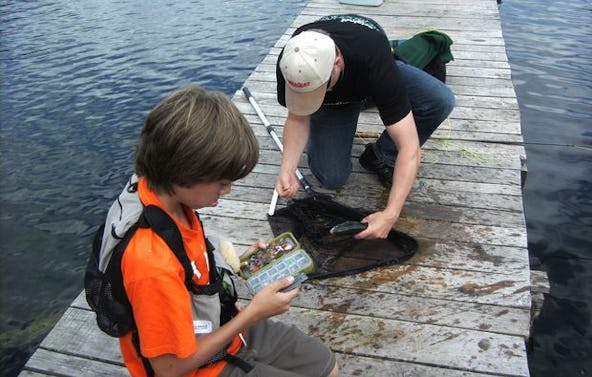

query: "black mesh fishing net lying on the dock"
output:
268 194 417 279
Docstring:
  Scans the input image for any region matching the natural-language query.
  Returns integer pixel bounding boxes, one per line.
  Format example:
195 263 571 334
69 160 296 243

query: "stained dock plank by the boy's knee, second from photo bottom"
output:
281 308 528 376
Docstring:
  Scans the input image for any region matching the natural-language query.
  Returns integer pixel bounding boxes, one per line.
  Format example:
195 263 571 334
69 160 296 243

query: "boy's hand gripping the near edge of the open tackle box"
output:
245 276 300 320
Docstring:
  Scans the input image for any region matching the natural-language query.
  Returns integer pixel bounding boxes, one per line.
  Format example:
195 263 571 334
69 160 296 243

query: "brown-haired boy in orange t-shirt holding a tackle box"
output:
115 87 338 377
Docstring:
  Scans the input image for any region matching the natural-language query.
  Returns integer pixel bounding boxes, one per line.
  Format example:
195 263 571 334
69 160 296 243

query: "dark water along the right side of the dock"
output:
500 0 592 377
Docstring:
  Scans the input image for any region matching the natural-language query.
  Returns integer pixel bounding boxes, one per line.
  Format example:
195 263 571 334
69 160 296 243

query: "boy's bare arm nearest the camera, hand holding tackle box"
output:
149 277 299 377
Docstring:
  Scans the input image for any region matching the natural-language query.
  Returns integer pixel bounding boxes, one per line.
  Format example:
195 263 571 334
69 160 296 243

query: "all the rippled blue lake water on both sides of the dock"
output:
0 0 592 377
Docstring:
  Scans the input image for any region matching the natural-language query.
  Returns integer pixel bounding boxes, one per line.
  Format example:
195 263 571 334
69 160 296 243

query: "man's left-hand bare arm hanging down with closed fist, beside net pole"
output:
275 113 310 197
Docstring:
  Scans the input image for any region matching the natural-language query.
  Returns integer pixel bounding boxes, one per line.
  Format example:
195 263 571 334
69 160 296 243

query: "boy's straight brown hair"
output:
135 86 259 193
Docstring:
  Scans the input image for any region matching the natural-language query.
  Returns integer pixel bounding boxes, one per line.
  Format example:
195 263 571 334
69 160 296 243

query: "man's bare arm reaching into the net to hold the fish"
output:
356 112 421 238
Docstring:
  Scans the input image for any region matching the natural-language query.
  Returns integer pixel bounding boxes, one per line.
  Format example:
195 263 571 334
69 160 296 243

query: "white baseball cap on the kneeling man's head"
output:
280 30 335 115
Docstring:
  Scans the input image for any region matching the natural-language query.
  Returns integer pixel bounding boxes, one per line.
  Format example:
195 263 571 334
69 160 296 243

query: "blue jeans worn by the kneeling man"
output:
307 60 454 189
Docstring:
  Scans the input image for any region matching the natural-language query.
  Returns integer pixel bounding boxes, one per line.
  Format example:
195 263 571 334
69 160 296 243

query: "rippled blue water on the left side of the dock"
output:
0 0 303 376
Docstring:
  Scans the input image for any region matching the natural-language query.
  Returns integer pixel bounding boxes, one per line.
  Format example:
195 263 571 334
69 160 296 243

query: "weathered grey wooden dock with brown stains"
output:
21 0 532 377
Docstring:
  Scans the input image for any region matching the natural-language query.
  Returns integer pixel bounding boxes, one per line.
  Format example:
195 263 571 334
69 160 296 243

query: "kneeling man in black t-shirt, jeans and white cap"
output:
276 15 454 238
